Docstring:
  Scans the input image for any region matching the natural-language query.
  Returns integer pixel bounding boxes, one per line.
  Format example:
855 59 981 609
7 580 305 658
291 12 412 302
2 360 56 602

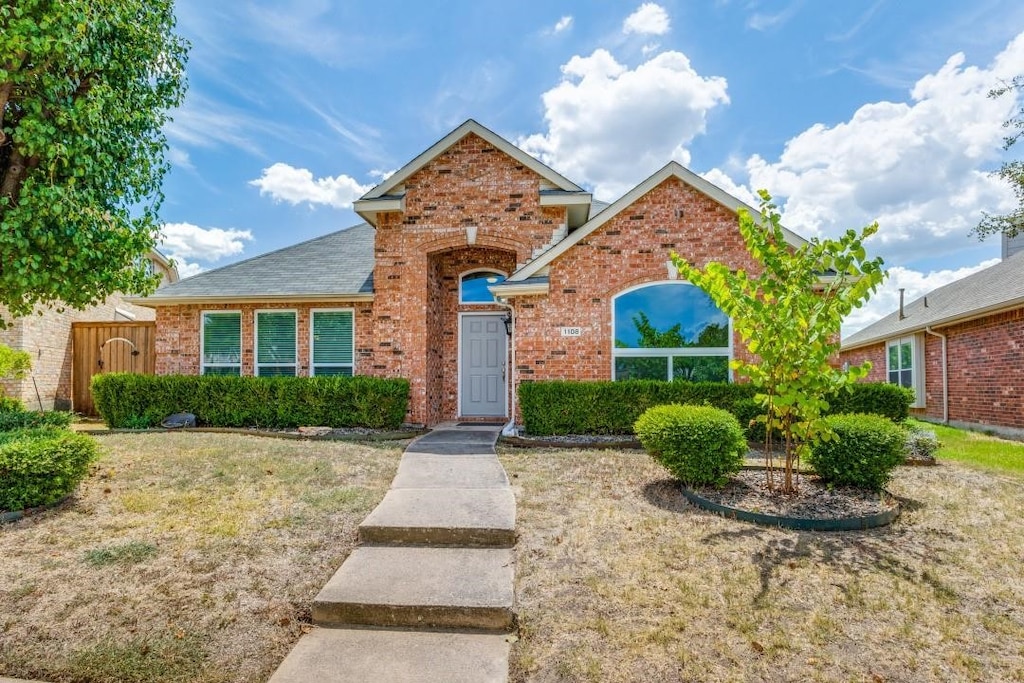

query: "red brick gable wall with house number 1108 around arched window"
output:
515 178 757 389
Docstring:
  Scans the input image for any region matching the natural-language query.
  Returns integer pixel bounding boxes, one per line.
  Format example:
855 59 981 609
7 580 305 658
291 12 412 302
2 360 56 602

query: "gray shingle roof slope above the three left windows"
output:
140 223 374 304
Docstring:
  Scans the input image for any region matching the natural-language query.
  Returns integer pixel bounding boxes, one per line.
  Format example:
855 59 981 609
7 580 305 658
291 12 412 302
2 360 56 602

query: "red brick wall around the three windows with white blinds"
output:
156 302 374 377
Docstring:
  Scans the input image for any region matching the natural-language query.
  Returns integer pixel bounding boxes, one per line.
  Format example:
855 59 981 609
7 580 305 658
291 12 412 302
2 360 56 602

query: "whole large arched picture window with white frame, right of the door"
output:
612 283 732 382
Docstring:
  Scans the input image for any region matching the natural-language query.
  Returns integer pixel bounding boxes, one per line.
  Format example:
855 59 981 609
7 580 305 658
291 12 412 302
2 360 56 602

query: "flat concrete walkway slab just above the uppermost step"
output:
391 453 509 488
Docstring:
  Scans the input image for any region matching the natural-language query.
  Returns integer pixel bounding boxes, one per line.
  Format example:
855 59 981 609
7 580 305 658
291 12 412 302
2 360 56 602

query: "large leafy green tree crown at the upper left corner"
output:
0 0 186 323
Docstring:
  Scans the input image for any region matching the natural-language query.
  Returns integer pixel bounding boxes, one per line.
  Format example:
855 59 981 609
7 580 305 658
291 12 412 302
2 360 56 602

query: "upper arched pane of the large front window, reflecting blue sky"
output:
614 284 729 348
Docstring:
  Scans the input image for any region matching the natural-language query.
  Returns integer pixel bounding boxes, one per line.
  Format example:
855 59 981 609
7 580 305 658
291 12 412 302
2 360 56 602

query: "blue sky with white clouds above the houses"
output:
157 0 1024 333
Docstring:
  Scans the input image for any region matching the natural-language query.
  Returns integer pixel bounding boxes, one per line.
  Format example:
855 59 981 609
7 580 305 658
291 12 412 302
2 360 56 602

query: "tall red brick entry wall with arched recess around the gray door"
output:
373 134 565 423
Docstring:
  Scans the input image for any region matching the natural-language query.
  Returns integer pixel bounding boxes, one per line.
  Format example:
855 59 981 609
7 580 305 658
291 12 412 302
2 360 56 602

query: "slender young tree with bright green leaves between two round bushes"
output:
672 190 886 493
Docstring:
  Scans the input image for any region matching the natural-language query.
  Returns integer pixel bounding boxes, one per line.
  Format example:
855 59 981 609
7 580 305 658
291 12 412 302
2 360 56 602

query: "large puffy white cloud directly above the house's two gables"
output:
517 49 729 199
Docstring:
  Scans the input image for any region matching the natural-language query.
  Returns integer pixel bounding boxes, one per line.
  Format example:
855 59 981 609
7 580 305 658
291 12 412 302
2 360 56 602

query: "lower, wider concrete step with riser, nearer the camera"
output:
312 546 514 631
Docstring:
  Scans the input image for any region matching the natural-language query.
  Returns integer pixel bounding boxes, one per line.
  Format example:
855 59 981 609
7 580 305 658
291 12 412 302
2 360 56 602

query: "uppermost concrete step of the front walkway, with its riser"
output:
359 487 515 548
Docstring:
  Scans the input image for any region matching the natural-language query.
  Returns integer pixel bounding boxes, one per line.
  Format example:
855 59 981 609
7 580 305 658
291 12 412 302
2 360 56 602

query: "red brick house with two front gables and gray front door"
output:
133 121 804 425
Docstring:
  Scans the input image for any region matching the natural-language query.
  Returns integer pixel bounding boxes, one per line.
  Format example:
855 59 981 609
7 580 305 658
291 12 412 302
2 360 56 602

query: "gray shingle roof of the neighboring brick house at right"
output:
843 252 1024 349
